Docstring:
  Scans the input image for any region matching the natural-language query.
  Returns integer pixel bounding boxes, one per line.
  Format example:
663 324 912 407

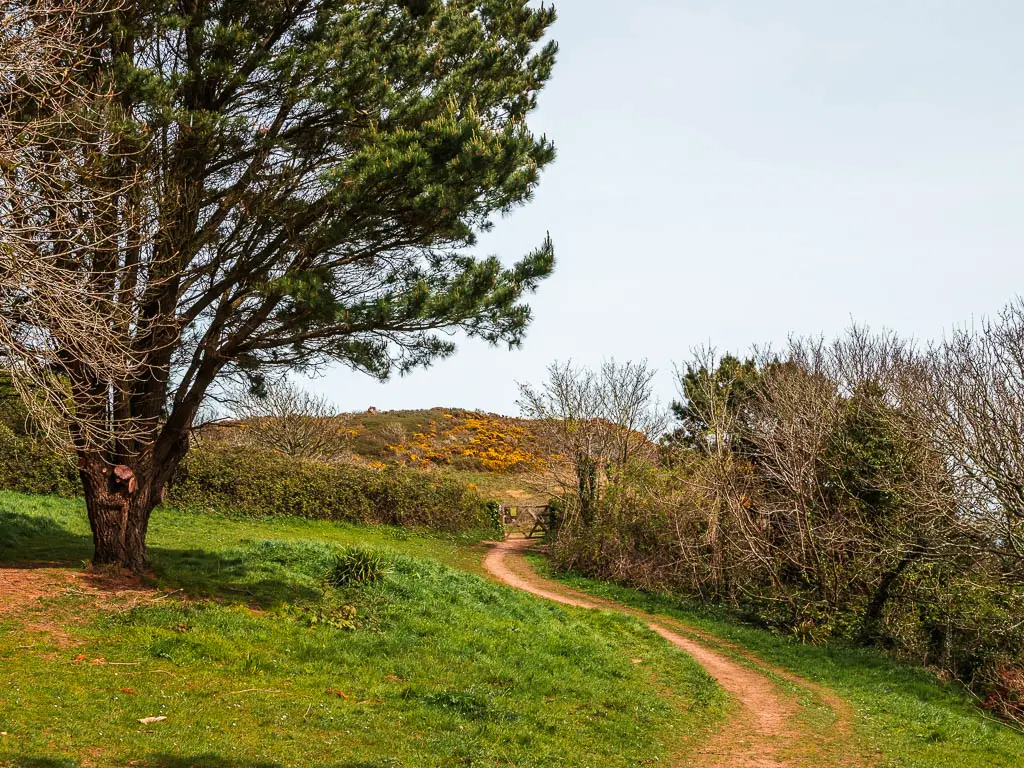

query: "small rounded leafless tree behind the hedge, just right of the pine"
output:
230 381 350 461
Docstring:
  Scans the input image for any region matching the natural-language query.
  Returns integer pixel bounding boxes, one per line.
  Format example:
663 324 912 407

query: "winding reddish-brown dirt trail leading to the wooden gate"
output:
483 539 872 768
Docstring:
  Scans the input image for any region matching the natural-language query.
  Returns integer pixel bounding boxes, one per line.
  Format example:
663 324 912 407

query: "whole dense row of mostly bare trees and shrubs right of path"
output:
552 303 1024 718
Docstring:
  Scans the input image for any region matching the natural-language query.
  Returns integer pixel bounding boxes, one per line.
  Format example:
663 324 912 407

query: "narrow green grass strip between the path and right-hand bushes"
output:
531 557 1024 768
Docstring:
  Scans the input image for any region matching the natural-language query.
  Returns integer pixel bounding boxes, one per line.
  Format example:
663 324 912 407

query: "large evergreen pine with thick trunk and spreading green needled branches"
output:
0 0 556 569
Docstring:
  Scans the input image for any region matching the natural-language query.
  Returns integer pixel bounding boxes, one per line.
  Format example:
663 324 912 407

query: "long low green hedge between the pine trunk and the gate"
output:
167 449 490 531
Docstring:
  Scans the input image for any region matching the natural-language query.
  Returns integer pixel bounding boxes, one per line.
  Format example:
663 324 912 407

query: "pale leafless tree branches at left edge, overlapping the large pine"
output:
0 0 155 456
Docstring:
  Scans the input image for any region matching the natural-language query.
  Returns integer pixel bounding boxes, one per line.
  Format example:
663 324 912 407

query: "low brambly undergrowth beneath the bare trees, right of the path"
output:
550 486 1024 722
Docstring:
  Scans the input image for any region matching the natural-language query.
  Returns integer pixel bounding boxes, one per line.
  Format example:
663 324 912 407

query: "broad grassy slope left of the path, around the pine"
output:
0 494 726 768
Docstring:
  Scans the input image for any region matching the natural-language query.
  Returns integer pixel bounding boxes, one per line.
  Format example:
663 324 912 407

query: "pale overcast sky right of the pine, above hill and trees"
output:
299 0 1024 414
